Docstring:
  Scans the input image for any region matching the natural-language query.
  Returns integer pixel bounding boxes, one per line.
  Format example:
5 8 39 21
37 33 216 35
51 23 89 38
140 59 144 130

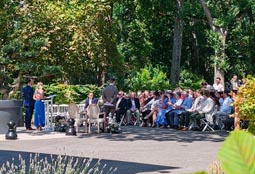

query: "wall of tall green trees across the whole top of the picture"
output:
0 0 255 96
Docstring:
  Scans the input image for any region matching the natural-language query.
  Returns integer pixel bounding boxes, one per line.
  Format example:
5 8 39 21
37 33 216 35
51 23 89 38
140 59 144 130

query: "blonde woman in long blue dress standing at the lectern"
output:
33 82 45 130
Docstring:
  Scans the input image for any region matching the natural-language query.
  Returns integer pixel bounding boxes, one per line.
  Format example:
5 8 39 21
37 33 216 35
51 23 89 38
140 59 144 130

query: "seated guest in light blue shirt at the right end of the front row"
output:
214 90 233 129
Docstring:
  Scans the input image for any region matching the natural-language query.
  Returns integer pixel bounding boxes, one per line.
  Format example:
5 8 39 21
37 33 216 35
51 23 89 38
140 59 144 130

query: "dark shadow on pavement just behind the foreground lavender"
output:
0 150 179 174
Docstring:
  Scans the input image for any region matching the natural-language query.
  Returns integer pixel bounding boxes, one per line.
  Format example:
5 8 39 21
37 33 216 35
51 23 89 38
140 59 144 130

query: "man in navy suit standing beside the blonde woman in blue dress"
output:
22 79 35 130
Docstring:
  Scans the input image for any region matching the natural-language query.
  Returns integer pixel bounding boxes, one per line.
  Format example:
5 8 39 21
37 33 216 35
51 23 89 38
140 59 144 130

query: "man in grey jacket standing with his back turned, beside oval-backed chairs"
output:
102 78 118 117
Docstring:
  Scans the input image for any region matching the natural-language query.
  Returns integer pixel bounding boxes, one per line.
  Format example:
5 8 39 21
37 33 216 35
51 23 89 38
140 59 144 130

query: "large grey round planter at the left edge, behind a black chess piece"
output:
0 100 24 134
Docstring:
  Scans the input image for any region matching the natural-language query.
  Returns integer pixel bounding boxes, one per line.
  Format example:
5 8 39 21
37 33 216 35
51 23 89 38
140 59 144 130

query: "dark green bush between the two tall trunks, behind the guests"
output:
179 69 204 90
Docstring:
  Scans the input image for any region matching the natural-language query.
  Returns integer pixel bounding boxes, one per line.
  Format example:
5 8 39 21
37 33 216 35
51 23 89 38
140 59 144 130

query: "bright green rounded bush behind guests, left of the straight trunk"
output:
126 66 169 91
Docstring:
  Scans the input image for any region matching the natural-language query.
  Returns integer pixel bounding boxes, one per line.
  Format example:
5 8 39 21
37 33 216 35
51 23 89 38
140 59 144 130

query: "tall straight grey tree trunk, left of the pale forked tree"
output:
170 0 183 85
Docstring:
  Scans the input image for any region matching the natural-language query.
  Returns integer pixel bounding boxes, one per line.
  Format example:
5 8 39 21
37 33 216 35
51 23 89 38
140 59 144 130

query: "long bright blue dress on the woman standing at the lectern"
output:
34 93 45 128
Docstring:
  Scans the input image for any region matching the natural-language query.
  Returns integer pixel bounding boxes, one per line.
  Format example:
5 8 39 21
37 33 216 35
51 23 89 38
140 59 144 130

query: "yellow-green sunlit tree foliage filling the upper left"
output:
0 0 123 84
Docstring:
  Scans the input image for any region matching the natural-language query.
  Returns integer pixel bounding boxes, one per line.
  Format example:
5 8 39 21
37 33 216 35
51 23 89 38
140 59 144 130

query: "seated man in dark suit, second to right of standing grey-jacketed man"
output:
126 92 140 125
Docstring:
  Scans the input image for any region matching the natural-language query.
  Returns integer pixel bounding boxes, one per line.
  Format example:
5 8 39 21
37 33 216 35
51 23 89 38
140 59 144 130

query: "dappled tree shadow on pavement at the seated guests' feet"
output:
78 126 229 143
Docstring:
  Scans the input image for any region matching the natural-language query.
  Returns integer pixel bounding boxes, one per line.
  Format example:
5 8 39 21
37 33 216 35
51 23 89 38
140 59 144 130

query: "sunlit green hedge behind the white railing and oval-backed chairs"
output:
44 84 101 104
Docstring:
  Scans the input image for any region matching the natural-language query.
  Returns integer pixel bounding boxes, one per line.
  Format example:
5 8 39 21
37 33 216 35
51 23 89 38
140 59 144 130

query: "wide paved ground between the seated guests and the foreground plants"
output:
0 126 228 174
